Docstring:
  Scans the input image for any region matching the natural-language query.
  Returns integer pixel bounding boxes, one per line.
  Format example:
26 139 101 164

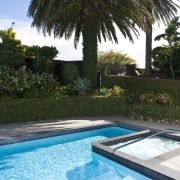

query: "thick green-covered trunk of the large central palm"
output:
82 19 98 88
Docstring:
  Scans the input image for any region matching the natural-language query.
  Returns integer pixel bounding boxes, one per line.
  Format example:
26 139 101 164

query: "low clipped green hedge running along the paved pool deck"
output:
0 97 180 124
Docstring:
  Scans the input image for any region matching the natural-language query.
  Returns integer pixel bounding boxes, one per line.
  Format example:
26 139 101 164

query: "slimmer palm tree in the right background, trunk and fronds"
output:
144 0 178 74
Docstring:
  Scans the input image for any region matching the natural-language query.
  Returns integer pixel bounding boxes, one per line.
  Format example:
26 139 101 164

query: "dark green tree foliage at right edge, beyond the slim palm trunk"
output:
152 17 180 78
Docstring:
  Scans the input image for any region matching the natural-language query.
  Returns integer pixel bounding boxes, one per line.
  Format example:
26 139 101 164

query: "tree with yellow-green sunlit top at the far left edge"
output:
0 28 25 68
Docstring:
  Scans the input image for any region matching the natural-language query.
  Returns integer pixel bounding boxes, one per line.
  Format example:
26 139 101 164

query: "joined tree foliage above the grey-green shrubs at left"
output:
0 28 58 72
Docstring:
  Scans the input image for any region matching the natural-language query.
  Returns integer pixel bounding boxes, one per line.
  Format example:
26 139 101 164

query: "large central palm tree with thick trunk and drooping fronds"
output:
28 0 153 87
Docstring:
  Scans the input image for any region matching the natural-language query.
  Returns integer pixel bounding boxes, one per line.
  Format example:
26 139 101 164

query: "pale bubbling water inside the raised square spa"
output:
111 136 180 160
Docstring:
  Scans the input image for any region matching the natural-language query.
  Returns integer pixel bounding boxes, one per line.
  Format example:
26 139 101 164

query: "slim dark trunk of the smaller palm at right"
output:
145 24 152 74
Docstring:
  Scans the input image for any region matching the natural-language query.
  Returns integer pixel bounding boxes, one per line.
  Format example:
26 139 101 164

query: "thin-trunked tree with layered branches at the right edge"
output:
154 17 180 79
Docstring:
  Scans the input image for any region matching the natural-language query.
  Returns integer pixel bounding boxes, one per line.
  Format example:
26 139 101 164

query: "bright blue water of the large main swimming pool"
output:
0 127 149 180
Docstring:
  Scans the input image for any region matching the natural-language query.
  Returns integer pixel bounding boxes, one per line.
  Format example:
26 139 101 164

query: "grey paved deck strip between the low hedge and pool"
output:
0 116 180 140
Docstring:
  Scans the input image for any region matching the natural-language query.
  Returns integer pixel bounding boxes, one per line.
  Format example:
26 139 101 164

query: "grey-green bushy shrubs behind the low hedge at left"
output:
0 66 59 97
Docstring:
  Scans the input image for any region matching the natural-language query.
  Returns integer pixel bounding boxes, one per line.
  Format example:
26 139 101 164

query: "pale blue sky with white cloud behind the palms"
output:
0 0 179 68
